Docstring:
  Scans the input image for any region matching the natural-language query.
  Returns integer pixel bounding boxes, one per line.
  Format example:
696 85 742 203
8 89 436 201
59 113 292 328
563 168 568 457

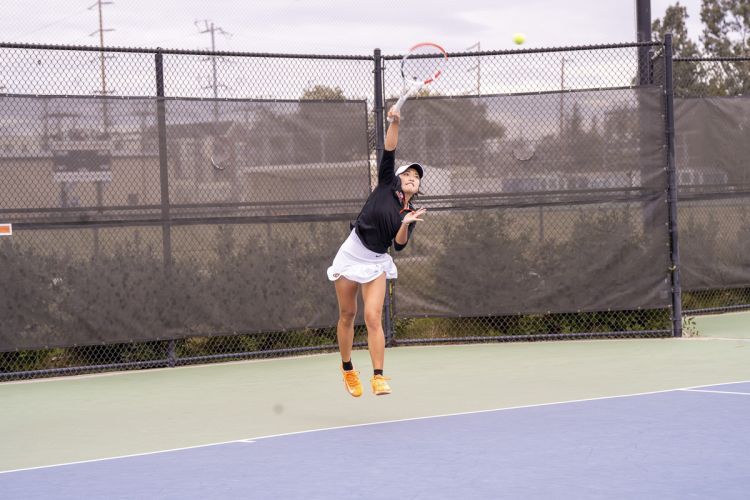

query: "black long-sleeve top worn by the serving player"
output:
354 150 415 253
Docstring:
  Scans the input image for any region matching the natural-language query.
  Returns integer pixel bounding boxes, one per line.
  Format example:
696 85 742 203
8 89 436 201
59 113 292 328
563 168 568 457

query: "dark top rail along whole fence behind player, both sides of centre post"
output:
0 42 662 61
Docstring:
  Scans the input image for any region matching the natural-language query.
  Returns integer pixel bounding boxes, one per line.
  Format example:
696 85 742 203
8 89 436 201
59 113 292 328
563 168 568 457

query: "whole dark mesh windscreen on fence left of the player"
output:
0 96 372 350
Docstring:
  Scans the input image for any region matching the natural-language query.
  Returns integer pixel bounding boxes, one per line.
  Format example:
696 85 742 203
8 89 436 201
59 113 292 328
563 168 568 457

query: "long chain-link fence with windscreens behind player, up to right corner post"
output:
0 40 720 379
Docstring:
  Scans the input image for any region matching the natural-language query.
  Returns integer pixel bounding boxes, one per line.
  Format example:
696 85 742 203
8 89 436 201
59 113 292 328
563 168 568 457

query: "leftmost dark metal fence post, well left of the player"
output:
154 49 176 366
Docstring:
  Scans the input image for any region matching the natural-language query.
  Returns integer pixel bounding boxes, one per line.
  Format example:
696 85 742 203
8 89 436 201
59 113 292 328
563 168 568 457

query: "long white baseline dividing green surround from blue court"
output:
0 380 750 475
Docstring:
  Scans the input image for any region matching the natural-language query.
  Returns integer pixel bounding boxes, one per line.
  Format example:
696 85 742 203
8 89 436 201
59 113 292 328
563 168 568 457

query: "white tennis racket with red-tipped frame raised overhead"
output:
388 42 448 122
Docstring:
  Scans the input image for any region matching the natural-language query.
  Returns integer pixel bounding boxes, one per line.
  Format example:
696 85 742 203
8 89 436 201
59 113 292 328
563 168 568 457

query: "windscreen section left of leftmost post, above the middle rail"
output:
0 96 160 222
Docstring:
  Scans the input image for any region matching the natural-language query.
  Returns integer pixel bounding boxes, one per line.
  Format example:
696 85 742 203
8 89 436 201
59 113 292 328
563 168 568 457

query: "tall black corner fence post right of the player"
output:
664 33 682 337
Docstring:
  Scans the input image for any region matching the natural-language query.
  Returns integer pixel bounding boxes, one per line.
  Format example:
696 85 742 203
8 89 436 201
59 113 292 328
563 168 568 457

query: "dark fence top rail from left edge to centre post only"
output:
0 42 375 61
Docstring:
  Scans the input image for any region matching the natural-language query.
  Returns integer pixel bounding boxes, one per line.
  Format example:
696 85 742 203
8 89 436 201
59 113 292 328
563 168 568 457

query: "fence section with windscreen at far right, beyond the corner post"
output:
674 57 750 313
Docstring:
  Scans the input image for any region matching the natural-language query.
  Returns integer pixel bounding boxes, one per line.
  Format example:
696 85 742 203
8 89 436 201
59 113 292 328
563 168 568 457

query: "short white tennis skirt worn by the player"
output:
328 229 398 283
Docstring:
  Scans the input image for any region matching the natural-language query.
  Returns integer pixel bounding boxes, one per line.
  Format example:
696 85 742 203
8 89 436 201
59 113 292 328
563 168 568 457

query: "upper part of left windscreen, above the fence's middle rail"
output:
0 96 370 222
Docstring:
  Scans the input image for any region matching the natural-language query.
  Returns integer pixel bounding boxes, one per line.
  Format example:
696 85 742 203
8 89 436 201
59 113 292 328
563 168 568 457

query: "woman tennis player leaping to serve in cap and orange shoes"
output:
328 107 426 397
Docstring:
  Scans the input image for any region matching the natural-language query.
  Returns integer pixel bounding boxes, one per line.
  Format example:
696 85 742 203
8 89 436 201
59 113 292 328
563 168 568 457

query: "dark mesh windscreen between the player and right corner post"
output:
395 88 670 317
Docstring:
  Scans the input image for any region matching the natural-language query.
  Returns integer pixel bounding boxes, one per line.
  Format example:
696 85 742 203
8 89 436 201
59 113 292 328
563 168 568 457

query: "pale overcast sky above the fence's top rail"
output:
0 0 701 55
